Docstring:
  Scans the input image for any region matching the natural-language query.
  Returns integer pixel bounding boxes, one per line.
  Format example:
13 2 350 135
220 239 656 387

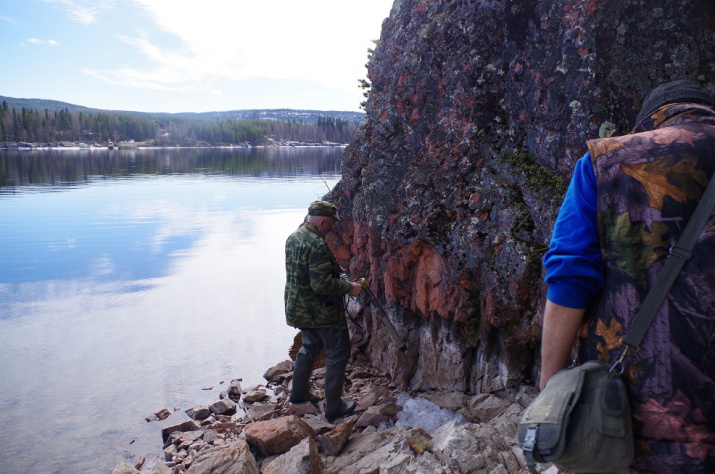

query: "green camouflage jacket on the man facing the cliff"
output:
284 222 351 328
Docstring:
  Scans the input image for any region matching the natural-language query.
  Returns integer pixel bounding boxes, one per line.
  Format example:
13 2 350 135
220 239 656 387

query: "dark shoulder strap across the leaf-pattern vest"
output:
623 175 715 347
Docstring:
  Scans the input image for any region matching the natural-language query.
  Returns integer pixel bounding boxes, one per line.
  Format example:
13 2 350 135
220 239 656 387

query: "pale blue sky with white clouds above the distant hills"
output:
0 0 393 112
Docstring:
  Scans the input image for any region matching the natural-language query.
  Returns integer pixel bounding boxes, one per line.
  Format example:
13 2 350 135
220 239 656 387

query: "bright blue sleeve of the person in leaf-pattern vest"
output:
544 152 605 309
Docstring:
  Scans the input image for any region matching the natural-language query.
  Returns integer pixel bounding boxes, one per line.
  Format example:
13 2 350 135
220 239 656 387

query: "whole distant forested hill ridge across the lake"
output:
0 96 364 145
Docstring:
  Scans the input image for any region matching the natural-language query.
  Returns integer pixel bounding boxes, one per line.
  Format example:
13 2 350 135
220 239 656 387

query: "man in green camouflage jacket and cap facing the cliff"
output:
284 201 362 419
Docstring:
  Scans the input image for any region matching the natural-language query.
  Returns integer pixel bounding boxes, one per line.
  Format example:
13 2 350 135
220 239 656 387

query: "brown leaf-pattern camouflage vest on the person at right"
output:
578 104 715 473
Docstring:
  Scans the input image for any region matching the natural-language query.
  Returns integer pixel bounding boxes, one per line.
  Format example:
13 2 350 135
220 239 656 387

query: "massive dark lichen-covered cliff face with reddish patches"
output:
328 0 715 393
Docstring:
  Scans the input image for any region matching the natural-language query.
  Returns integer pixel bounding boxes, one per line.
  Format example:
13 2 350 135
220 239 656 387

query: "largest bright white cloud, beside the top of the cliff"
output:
83 0 391 100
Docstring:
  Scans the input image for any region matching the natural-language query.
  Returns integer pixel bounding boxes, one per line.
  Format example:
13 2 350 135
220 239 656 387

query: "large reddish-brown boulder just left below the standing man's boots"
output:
245 415 315 457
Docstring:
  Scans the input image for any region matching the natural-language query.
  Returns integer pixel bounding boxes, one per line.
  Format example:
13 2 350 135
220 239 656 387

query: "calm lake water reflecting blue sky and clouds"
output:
0 148 342 473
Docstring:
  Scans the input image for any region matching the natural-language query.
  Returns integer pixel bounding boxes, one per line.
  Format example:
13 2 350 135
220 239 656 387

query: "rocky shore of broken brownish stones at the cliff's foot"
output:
112 357 554 474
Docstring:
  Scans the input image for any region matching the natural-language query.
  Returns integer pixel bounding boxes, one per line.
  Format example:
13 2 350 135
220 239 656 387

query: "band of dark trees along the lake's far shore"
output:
0 100 357 146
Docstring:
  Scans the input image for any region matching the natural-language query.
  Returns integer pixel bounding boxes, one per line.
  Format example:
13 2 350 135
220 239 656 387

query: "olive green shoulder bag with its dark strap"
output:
517 178 715 473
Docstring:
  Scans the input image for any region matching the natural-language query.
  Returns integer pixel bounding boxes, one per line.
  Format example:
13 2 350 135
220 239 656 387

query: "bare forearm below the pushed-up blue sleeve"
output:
539 300 586 390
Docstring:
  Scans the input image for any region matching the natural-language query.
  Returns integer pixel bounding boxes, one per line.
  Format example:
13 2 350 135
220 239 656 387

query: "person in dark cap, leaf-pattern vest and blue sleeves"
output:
539 80 715 473
